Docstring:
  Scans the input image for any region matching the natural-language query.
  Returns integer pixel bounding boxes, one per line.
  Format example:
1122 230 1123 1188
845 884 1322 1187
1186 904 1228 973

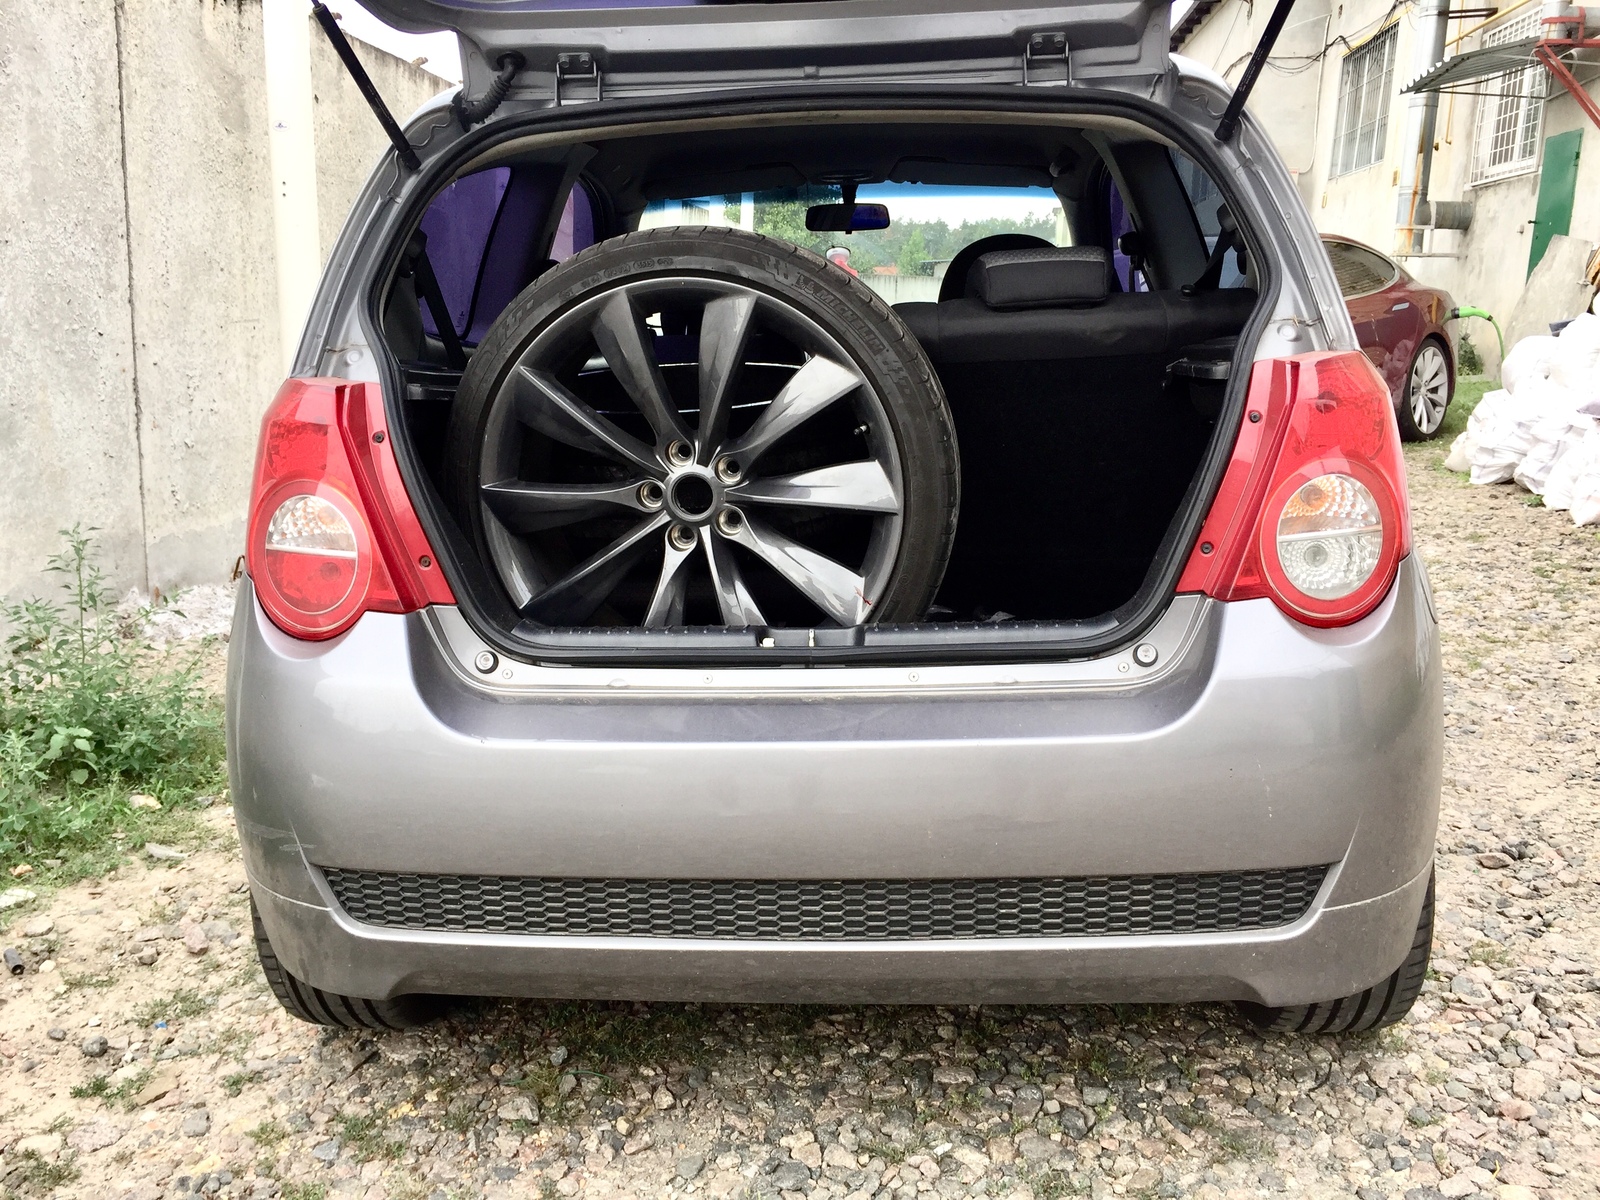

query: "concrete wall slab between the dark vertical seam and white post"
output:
122 0 278 590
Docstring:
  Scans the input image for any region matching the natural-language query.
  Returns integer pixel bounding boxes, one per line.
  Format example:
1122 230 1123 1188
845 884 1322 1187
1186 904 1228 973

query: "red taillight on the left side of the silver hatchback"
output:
246 379 454 638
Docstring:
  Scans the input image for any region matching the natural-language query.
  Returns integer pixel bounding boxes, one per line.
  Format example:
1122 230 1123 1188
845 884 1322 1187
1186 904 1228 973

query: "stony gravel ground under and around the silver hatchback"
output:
0 446 1600 1200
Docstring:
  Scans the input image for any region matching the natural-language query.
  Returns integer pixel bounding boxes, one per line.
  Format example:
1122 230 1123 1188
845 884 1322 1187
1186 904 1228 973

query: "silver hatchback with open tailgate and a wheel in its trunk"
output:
227 0 1442 1032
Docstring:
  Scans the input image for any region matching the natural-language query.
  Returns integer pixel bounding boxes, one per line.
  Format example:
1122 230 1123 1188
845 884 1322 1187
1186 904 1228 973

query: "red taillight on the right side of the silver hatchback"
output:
1178 352 1411 626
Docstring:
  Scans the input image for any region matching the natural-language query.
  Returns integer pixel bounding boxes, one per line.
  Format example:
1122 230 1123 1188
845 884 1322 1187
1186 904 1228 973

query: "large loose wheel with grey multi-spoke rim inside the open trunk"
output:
445 229 960 629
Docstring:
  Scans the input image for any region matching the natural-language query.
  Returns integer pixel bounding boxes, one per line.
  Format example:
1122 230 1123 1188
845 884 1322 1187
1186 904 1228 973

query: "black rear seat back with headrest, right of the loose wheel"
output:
894 246 1256 619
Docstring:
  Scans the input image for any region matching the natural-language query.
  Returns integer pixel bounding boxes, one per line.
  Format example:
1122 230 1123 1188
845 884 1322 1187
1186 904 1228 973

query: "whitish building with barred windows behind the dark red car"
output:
1173 0 1600 370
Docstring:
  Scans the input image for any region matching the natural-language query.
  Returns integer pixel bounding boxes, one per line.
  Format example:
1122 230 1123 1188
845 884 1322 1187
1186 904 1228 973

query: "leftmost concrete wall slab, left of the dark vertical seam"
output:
0 0 144 595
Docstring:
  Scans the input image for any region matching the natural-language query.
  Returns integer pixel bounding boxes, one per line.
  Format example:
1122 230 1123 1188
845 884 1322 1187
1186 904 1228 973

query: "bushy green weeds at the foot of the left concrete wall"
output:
0 526 222 877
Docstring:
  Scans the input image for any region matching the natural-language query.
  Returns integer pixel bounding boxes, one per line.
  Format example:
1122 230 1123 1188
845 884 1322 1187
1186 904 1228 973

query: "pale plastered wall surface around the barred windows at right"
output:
1181 0 1600 371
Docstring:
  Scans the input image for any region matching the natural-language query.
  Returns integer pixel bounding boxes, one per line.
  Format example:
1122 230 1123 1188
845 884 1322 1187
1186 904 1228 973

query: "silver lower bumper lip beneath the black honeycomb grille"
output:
253 870 1429 1005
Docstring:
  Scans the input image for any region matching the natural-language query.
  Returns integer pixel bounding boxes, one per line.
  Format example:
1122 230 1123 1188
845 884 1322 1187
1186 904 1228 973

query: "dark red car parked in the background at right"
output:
1322 234 1456 442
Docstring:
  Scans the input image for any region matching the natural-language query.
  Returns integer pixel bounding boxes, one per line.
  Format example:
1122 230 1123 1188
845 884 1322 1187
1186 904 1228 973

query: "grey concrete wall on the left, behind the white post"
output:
0 0 445 611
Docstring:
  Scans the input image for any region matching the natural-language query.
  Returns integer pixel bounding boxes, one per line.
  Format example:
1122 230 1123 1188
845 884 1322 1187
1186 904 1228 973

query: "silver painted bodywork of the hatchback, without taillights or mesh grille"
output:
227 54 1443 1005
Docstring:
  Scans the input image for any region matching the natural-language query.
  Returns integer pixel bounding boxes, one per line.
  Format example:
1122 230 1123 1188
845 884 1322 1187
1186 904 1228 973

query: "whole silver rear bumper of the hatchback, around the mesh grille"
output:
229 560 1442 1005
